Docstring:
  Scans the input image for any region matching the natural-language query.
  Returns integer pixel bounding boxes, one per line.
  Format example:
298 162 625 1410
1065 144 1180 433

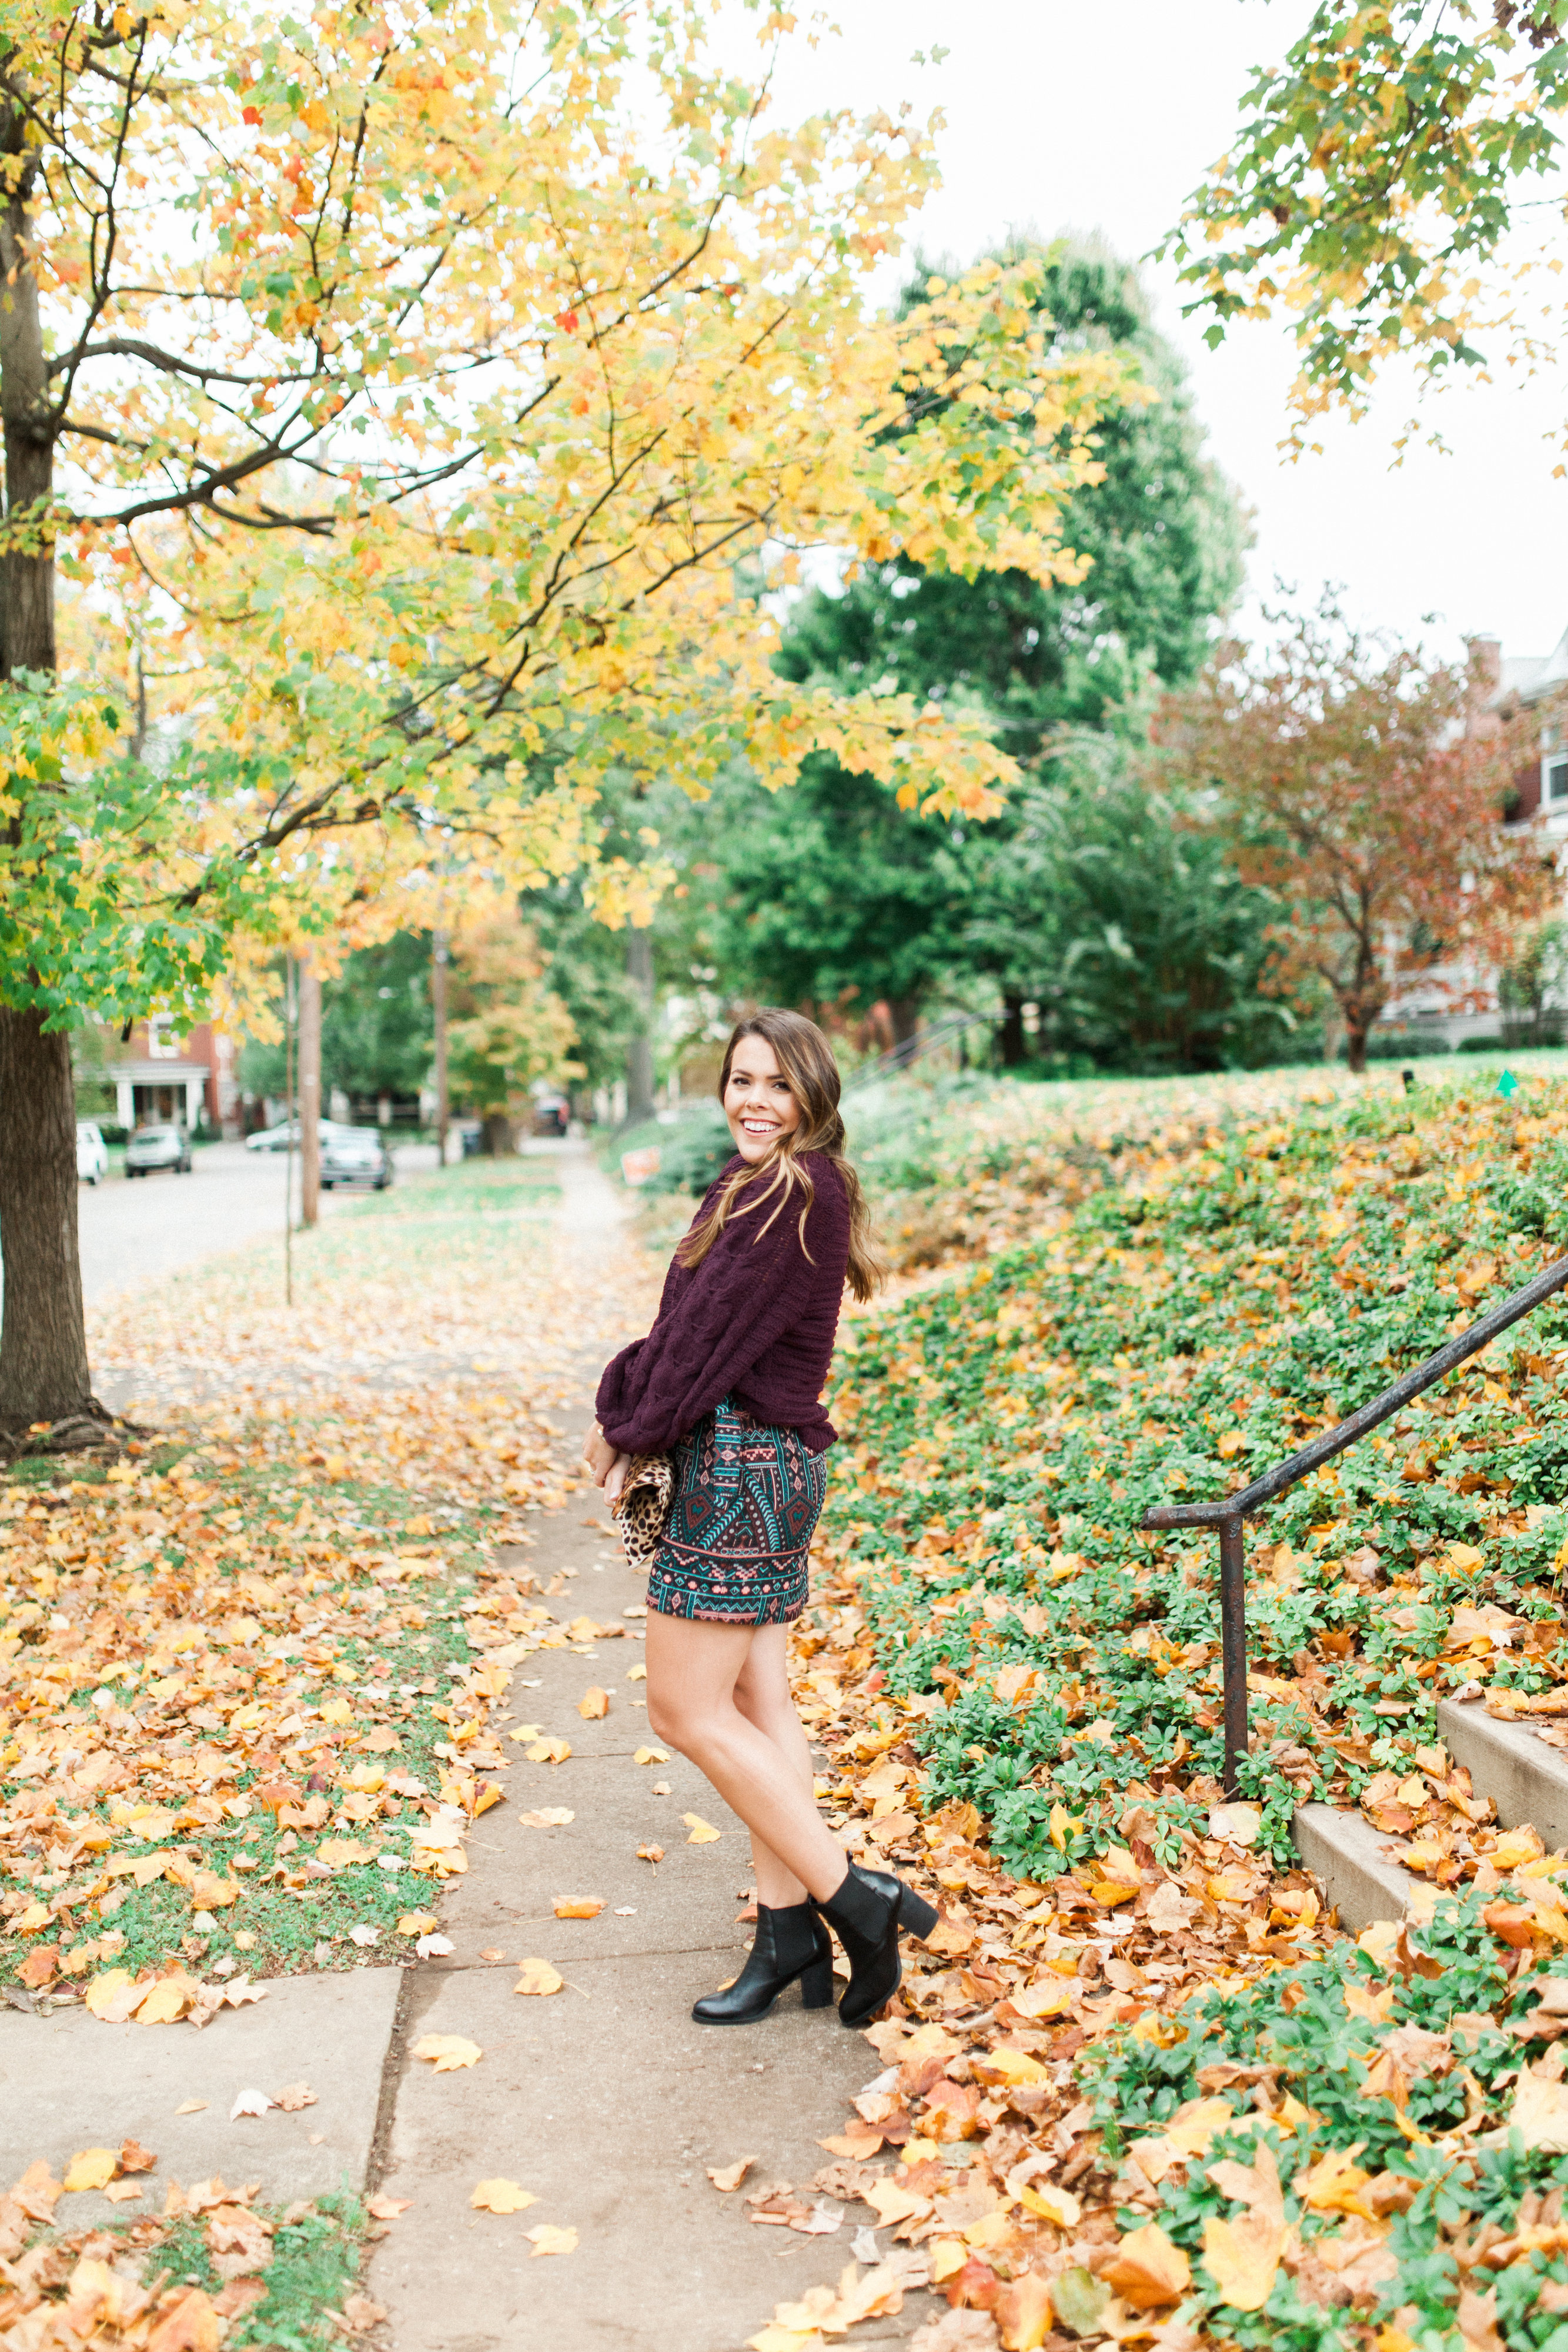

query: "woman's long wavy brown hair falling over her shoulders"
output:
675 1004 886 1301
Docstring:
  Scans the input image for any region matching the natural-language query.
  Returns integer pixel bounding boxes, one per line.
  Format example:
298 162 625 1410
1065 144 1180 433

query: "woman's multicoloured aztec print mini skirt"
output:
649 1397 827 1625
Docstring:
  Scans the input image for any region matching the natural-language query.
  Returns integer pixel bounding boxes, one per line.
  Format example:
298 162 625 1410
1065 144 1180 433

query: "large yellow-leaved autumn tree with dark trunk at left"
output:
0 0 1124 1442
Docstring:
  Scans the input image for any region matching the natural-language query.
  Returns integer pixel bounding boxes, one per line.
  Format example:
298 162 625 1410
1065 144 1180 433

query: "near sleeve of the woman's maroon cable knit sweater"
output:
597 1157 844 1454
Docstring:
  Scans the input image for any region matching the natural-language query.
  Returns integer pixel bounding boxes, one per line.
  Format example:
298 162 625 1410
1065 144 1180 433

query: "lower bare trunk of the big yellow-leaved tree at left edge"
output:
0 1004 106 1437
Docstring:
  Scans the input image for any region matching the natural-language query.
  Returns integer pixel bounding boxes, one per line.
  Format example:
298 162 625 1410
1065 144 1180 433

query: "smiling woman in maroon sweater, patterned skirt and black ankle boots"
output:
583 1011 935 2025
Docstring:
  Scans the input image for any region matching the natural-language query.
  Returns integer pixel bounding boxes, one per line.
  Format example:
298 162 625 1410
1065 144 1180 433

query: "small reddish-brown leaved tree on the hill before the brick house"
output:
1161 607 1552 1070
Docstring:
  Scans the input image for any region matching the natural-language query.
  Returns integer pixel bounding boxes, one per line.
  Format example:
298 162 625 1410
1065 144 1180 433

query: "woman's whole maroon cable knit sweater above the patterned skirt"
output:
597 1152 848 1454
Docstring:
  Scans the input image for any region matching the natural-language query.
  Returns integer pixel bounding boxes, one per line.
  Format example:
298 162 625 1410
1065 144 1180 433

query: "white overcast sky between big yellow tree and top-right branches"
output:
752 0 1568 673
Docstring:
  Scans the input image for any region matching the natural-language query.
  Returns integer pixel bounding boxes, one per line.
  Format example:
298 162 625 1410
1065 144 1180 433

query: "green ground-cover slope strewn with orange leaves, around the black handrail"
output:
757 1073 1568 2352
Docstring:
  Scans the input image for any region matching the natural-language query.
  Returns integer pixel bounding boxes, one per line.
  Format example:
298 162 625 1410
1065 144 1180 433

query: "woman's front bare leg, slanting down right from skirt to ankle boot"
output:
647 1611 848 1910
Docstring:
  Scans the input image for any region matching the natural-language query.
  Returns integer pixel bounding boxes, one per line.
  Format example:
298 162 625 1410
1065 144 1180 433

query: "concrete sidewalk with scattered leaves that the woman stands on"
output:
369 1155 945 2352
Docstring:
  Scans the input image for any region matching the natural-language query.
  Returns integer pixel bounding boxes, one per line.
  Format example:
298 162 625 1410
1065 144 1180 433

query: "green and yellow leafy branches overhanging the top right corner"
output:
1168 0 1568 440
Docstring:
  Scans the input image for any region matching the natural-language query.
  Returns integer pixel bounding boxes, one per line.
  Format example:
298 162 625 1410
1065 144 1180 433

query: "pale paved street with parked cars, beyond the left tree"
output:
78 1143 435 1305
